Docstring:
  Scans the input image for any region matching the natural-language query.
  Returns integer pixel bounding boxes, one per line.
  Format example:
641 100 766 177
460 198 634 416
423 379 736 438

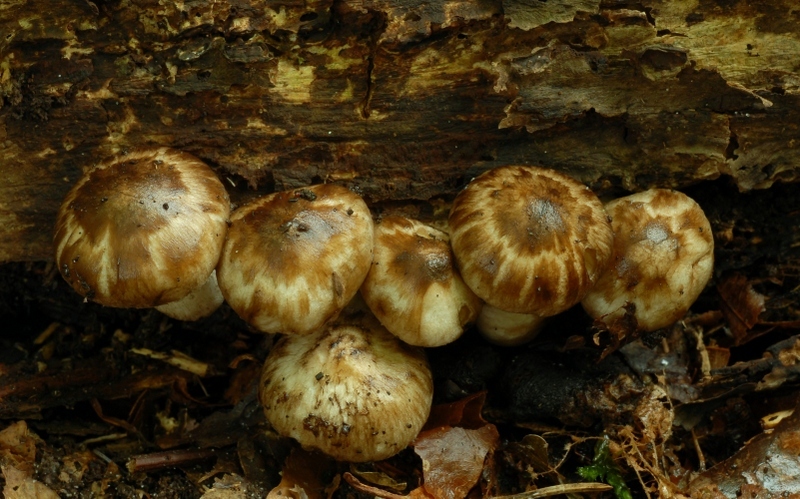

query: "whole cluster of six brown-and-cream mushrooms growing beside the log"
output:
54 148 713 461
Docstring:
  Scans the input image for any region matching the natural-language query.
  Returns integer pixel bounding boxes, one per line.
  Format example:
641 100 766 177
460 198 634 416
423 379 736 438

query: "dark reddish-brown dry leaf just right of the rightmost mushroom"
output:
717 273 766 345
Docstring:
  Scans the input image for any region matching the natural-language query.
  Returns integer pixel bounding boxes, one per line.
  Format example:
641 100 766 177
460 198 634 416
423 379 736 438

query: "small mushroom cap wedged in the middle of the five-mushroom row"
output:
361 216 481 347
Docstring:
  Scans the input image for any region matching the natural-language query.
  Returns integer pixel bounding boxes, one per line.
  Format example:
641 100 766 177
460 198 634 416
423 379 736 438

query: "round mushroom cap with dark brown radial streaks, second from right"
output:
449 166 612 317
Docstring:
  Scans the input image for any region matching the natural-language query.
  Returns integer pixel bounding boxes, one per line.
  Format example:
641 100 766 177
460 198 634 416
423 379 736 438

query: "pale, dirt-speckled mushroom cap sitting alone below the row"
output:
259 323 433 462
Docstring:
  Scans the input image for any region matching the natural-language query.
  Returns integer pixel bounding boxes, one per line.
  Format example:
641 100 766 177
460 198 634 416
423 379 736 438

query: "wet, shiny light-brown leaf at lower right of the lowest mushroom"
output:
414 424 500 499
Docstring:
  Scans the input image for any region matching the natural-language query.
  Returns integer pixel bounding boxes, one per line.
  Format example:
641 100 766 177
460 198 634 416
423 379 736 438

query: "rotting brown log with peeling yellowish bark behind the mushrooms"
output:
0 0 800 262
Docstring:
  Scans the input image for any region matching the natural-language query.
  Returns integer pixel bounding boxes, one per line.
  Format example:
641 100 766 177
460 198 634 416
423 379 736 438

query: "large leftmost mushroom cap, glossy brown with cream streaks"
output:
53 147 230 308
